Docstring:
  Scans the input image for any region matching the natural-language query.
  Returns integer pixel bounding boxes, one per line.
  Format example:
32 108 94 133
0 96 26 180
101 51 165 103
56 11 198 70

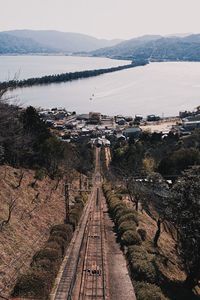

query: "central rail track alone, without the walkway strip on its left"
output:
78 188 107 300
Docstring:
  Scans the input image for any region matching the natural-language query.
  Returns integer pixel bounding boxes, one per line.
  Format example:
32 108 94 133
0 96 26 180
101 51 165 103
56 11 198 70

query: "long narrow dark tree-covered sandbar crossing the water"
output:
0 60 149 89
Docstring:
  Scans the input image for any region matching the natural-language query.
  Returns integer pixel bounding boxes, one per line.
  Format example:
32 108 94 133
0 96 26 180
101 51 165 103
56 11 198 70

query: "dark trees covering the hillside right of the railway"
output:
106 130 200 299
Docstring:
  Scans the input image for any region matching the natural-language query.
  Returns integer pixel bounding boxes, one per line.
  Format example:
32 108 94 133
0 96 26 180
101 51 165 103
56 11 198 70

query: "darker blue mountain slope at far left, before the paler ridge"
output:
0 32 53 54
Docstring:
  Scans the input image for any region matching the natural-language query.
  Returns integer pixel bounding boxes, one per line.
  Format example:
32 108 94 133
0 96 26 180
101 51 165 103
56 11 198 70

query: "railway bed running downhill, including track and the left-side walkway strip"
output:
51 149 109 300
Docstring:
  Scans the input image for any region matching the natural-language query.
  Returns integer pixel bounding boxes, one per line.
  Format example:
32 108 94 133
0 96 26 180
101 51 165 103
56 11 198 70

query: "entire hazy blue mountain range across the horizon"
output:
0 30 200 61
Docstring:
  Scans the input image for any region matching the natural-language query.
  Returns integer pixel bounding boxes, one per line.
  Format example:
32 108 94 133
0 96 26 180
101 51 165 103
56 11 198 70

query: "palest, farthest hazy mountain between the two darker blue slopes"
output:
2 30 121 53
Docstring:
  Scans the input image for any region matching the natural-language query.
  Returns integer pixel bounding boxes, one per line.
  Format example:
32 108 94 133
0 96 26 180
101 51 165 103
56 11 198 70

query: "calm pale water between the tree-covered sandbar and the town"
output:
4 58 200 116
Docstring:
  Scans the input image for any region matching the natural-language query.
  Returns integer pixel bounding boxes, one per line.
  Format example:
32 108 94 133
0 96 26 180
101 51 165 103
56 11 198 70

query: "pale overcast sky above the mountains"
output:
0 0 200 39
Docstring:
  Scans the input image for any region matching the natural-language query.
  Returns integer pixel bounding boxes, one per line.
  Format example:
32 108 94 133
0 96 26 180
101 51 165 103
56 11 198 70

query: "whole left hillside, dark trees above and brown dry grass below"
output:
0 91 94 296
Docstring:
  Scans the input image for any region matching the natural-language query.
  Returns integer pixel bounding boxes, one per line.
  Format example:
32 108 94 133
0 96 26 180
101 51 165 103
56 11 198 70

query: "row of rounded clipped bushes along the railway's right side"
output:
103 184 167 300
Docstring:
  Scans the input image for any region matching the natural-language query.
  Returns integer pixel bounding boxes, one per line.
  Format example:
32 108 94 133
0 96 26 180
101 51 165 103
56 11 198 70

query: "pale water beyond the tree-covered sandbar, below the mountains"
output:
0 56 128 81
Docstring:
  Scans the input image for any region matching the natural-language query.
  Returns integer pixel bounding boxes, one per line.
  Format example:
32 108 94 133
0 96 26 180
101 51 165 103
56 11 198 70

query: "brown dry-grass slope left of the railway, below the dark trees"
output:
0 166 81 296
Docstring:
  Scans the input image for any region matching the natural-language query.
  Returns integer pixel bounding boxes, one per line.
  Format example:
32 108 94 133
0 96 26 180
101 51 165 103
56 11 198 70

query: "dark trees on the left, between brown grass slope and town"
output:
0 89 93 177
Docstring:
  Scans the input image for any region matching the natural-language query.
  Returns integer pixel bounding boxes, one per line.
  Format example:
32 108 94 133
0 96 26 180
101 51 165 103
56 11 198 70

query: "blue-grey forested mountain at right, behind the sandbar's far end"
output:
91 34 200 61
